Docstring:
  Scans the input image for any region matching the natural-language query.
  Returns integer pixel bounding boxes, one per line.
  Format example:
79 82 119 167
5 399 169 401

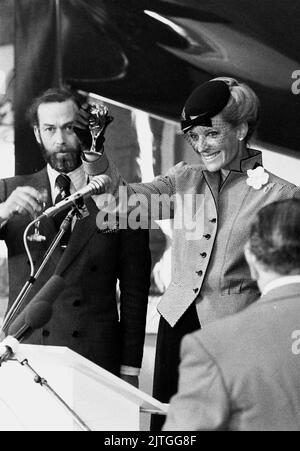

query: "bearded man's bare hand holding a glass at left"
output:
0 186 44 223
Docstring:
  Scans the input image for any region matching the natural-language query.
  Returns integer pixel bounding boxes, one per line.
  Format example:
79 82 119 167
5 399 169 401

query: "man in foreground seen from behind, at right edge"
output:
164 199 300 431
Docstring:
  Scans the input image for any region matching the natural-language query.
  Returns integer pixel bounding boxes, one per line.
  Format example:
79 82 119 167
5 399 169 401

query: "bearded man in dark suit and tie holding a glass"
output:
0 89 150 386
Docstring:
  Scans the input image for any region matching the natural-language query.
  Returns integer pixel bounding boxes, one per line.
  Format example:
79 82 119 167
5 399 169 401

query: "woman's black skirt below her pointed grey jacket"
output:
150 302 200 431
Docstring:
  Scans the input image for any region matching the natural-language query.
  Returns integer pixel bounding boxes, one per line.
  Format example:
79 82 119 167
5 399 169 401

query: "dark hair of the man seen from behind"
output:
250 198 300 275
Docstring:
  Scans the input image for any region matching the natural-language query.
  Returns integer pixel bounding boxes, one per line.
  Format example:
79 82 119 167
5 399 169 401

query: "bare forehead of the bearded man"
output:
37 99 78 123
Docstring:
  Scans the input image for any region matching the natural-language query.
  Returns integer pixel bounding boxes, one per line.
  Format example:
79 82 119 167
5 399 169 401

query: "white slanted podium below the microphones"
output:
0 345 167 431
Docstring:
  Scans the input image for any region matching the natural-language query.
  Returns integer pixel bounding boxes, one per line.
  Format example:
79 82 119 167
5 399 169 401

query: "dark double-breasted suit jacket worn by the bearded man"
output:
0 169 150 374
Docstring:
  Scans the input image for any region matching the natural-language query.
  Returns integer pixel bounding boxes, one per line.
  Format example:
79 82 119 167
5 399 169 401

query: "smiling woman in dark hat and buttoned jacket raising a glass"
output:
75 78 300 429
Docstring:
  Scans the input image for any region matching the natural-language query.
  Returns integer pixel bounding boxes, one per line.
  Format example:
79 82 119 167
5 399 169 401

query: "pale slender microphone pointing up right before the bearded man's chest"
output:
38 174 111 219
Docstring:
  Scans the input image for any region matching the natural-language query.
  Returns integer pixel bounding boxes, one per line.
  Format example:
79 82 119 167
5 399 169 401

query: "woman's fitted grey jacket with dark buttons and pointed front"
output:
85 149 300 327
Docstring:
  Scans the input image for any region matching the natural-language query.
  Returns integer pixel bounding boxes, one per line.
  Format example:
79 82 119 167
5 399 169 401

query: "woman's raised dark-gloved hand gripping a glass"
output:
74 103 113 153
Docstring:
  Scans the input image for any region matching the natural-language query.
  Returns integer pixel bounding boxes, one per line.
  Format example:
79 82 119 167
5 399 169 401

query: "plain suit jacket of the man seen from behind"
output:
164 283 300 431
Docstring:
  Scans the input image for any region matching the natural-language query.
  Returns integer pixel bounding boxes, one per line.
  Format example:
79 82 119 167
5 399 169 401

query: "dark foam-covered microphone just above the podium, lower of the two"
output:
8 275 65 340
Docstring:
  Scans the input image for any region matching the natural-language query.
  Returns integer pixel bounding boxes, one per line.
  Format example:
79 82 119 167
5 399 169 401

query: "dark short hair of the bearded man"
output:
27 88 82 127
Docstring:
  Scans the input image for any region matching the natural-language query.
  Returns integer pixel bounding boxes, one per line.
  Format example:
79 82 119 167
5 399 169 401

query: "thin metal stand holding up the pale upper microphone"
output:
1 205 82 332
